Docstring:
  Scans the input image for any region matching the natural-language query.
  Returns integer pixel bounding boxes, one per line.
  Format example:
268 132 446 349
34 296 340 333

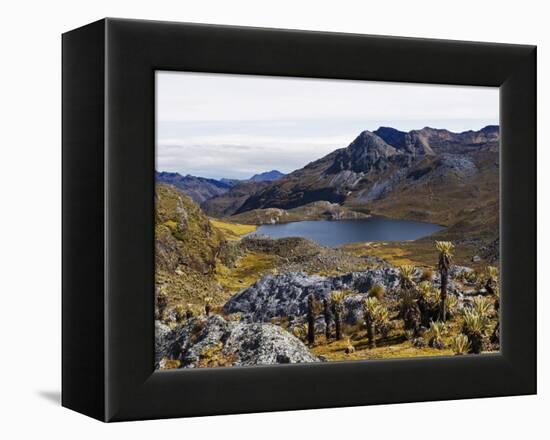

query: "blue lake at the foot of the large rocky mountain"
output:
249 217 443 247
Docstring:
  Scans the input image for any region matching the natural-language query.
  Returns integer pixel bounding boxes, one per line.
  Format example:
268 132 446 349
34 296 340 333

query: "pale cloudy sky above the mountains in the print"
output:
156 71 499 179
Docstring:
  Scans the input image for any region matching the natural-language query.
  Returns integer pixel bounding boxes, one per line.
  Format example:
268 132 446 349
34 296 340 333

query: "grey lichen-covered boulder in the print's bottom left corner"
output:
156 315 319 368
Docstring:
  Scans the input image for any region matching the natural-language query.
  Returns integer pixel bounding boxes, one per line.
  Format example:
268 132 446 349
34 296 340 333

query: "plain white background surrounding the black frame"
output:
0 0 550 440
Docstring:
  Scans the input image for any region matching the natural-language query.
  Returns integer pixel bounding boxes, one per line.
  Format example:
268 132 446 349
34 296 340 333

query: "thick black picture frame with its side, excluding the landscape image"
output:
62 19 536 421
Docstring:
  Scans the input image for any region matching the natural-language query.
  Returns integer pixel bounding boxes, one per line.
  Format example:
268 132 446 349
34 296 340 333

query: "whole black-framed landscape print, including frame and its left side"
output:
62 19 536 421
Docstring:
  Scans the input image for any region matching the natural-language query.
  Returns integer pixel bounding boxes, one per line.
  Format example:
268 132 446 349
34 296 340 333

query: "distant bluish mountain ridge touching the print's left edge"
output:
155 171 233 204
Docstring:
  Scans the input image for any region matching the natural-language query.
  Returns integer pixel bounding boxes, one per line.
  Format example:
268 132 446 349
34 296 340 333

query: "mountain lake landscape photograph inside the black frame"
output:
154 71 500 370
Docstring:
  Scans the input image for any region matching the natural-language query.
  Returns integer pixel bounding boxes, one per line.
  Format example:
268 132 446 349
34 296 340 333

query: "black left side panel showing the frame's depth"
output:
62 20 105 420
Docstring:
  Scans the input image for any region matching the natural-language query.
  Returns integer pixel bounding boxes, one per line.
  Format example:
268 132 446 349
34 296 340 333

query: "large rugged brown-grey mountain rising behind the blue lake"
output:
235 126 500 244
